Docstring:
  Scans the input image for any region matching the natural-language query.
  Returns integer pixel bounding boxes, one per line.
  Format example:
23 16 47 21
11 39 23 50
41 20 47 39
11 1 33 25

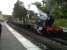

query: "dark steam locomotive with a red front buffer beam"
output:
7 4 63 35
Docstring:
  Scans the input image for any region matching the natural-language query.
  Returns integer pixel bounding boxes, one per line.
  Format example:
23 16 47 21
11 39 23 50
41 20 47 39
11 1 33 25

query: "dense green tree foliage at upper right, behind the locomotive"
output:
37 0 67 18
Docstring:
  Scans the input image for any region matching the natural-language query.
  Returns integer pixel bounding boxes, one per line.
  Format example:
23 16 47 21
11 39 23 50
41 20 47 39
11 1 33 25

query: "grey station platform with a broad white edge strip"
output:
0 23 40 50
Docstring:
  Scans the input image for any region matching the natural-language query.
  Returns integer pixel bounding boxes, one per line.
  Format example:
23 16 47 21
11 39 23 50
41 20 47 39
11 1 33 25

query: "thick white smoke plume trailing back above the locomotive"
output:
22 3 48 20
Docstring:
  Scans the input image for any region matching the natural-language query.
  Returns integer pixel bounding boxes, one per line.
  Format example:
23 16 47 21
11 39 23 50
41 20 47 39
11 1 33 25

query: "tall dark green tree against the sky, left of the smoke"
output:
13 0 27 23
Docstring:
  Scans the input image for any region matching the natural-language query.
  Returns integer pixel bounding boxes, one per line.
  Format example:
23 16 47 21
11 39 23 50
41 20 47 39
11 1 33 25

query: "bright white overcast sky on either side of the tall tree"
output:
0 0 42 15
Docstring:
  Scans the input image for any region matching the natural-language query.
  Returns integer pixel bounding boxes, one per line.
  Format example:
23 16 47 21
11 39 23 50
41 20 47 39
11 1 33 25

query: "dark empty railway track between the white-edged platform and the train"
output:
7 22 67 50
